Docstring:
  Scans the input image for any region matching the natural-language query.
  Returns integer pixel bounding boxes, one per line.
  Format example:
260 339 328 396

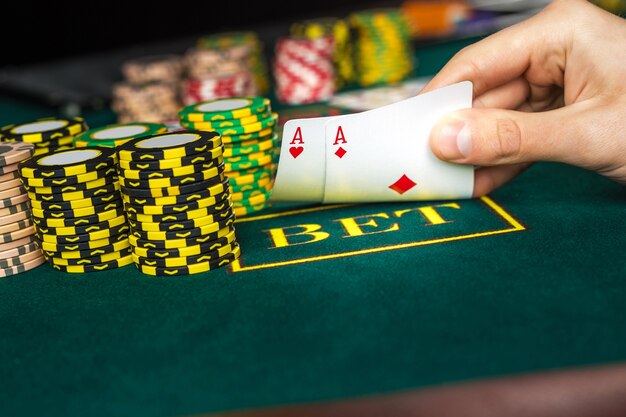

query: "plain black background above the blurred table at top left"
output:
0 0 394 68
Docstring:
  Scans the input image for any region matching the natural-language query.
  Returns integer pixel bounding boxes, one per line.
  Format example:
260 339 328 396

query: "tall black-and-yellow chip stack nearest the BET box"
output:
117 130 241 273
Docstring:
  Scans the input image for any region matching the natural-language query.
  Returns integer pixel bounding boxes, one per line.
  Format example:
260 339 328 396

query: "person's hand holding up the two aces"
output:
422 0 626 197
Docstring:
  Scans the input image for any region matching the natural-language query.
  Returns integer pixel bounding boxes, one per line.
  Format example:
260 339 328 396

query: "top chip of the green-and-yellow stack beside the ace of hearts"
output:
178 97 270 122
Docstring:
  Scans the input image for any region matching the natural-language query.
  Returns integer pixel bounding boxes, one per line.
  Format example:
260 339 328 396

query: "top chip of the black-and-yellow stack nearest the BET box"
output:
118 130 222 162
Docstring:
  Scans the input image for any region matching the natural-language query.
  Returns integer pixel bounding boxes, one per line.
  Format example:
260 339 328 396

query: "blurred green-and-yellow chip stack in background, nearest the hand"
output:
349 8 414 87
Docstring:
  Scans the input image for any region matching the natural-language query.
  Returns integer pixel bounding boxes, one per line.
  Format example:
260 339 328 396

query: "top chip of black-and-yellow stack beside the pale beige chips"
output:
19 148 117 178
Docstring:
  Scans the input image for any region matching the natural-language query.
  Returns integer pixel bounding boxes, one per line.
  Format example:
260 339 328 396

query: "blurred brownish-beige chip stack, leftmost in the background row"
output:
111 55 183 123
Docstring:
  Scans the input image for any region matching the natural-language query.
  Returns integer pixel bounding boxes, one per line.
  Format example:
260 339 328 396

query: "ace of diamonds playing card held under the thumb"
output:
322 81 474 203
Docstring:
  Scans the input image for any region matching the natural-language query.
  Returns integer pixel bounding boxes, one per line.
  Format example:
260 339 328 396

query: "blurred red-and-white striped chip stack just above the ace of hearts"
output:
274 36 335 104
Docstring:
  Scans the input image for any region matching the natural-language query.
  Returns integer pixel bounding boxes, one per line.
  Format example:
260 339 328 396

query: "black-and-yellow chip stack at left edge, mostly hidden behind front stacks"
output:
0 117 88 156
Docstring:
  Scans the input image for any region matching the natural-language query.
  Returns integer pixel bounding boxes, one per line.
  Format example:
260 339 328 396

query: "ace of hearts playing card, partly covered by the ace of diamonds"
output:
271 117 333 202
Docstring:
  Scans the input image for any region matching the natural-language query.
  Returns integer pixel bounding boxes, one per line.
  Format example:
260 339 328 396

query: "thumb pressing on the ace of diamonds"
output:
430 108 582 166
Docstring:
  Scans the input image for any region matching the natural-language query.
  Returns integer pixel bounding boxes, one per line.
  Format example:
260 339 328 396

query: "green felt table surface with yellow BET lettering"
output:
0 38 626 417
